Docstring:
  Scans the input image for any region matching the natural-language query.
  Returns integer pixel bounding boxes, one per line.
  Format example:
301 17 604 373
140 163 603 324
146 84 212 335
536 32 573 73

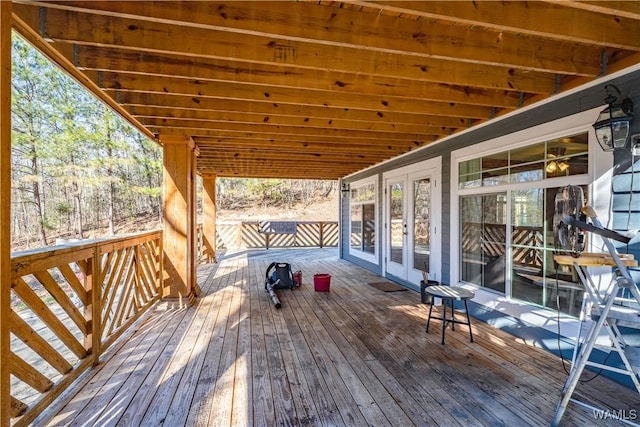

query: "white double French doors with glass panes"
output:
384 158 441 284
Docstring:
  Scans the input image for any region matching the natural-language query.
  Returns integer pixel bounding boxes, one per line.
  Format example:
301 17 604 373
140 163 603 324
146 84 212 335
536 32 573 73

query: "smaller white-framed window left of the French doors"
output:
349 180 377 262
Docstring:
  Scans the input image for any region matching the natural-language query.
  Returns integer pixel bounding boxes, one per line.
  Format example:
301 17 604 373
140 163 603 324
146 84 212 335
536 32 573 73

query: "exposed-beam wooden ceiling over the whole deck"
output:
8 1 640 179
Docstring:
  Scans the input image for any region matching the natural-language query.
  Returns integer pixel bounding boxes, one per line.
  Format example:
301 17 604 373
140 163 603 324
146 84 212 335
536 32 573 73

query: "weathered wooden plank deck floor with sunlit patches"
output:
42 249 640 426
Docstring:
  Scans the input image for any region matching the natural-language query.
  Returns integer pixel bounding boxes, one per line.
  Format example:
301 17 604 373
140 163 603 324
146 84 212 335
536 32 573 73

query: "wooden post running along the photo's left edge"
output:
0 1 12 427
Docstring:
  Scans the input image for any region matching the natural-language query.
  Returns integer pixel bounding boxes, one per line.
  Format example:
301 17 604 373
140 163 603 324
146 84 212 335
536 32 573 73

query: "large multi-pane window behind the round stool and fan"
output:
458 132 589 315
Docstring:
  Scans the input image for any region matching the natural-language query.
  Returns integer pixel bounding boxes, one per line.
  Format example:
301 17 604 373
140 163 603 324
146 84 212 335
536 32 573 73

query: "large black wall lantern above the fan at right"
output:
593 85 633 151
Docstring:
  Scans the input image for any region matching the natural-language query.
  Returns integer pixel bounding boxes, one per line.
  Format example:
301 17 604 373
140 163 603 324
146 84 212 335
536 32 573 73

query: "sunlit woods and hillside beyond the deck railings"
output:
10 34 337 251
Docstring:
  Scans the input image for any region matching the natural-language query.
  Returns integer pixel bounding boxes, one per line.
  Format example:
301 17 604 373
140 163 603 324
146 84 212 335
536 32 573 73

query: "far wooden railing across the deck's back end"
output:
198 221 338 252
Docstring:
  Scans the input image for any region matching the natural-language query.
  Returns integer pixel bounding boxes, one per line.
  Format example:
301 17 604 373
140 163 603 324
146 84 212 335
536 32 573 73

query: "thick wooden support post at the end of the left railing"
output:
160 136 197 305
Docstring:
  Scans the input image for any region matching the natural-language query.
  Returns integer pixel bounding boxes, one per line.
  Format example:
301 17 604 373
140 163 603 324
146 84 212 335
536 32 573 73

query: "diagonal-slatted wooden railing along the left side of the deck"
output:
8 231 162 426
